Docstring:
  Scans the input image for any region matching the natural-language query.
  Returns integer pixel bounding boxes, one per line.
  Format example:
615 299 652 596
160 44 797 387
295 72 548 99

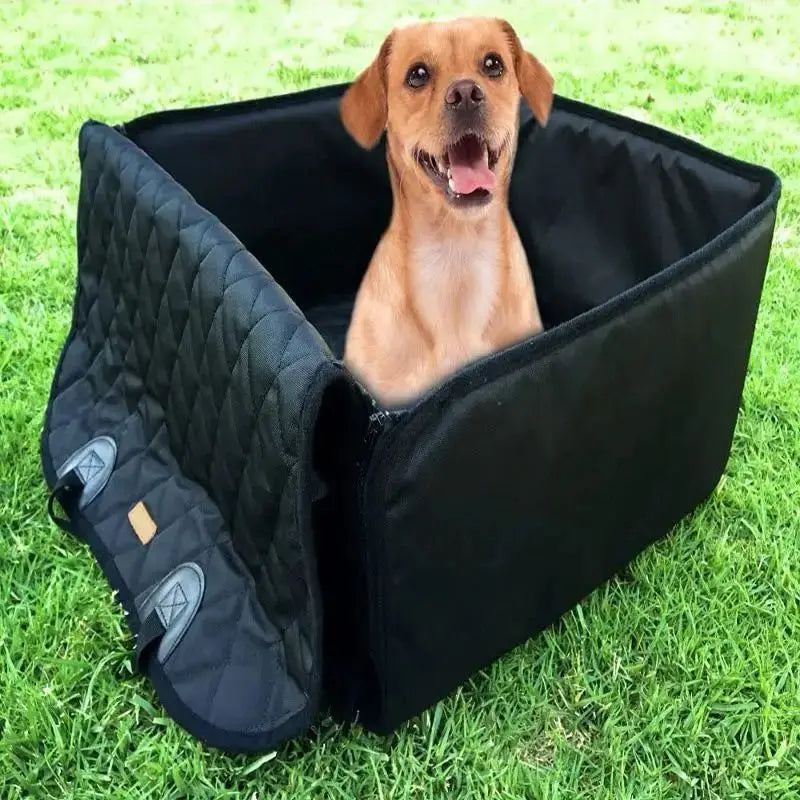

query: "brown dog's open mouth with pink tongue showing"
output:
416 134 500 205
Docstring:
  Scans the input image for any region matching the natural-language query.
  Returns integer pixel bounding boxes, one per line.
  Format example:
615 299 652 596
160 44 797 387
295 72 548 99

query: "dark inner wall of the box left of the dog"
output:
126 92 392 311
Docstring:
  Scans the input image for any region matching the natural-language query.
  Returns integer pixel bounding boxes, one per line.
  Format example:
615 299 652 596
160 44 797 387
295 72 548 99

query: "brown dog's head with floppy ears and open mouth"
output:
341 18 553 211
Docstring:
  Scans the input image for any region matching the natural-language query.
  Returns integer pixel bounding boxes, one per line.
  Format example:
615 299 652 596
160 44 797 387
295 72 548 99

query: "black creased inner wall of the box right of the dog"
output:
510 110 772 327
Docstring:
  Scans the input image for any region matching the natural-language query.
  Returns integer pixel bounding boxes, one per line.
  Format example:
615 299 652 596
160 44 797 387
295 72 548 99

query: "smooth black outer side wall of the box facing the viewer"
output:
366 211 775 731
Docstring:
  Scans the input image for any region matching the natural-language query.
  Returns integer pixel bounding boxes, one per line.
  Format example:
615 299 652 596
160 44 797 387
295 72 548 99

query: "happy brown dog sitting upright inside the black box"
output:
340 18 553 405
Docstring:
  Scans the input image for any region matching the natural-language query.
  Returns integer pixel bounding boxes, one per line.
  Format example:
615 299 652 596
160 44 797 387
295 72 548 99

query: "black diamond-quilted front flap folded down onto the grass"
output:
42 123 336 749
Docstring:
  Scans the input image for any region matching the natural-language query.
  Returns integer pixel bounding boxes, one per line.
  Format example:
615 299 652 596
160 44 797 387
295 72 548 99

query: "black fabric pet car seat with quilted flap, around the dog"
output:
41 86 780 751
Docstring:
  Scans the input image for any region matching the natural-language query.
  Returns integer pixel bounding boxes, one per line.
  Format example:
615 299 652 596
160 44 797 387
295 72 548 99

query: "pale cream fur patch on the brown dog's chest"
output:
412 227 500 350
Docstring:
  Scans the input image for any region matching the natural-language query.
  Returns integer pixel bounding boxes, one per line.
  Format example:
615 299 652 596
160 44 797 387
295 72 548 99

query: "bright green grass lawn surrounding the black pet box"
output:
0 0 800 800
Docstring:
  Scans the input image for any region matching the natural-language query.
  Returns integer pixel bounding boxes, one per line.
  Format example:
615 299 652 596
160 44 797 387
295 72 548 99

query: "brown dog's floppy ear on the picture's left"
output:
339 34 392 149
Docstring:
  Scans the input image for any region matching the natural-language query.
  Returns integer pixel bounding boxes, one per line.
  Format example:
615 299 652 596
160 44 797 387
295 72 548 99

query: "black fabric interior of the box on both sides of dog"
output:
126 87 773 326
